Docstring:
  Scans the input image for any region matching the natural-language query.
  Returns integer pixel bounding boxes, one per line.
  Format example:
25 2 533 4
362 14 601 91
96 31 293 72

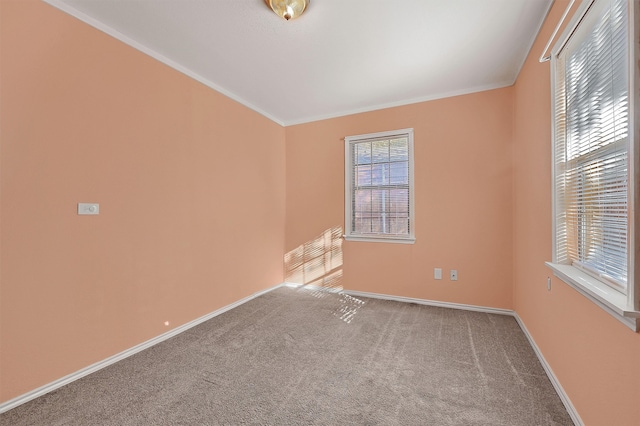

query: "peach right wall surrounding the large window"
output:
514 1 640 426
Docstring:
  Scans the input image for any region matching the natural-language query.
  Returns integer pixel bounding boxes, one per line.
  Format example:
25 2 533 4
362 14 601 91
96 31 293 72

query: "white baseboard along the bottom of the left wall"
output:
0 283 287 414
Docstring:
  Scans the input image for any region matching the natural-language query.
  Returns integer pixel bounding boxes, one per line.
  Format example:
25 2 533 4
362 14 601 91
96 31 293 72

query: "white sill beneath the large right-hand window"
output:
546 262 640 332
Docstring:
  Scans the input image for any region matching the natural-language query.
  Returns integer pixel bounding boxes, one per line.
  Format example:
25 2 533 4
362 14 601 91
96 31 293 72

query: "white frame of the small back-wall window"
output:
344 129 416 244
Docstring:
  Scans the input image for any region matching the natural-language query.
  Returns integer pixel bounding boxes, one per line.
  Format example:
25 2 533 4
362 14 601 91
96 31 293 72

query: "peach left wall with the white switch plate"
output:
0 0 285 401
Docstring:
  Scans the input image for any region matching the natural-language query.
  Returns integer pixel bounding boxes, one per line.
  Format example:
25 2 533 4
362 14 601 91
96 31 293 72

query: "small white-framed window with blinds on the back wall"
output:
345 129 415 243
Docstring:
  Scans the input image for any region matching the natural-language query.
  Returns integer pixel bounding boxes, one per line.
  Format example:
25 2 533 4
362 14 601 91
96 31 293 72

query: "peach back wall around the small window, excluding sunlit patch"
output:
285 88 512 309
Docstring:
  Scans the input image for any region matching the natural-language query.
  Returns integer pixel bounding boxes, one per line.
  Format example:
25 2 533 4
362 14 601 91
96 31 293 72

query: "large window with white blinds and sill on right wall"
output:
549 0 640 331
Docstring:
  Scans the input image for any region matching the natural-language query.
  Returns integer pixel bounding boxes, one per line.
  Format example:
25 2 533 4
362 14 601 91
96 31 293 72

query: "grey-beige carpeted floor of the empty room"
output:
0 287 573 426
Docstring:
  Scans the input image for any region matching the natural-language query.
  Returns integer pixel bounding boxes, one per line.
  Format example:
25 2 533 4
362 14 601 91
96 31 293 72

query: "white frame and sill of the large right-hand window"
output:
546 0 640 332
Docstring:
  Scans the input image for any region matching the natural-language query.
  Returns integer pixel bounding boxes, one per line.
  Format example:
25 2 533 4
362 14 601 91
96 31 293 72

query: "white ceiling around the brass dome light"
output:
44 0 553 125
